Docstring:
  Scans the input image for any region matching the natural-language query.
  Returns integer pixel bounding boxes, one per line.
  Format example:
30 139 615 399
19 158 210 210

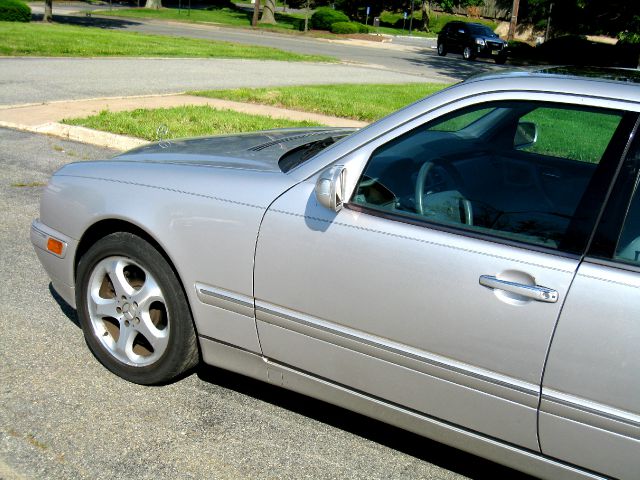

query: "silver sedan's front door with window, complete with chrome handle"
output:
255 97 628 450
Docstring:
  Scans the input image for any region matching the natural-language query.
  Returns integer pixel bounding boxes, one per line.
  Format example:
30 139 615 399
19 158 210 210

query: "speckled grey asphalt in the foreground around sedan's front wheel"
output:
0 129 523 480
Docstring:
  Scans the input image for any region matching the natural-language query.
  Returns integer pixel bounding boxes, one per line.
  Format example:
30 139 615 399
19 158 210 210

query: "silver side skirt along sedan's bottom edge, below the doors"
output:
200 336 603 480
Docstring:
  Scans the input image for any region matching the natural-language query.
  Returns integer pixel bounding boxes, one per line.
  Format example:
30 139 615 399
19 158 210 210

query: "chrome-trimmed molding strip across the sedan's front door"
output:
256 300 539 400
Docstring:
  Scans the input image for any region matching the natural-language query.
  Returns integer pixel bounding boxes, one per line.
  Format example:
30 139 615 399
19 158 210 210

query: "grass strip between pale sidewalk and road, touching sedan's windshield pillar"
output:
190 83 447 122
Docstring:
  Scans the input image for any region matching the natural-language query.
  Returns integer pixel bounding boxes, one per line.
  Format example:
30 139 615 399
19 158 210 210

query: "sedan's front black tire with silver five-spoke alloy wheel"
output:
76 232 199 385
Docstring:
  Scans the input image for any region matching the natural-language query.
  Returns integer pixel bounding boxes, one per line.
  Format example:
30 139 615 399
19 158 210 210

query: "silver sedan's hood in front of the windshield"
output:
113 128 355 171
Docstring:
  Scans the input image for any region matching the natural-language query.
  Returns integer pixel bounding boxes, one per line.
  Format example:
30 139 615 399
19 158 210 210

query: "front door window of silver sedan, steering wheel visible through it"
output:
352 101 622 255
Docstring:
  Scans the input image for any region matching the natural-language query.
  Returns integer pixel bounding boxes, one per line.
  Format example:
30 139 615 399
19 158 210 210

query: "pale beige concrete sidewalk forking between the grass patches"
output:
0 94 367 150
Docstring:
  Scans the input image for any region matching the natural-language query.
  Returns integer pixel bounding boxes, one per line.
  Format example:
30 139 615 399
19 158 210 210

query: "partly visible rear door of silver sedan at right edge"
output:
540 129 640 479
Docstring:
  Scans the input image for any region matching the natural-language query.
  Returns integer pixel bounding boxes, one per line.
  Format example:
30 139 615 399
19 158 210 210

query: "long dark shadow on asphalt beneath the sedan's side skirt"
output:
197 364 533 480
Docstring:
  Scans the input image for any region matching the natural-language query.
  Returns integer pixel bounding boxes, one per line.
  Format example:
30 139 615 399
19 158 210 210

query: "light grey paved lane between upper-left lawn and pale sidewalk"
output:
0 57 424 105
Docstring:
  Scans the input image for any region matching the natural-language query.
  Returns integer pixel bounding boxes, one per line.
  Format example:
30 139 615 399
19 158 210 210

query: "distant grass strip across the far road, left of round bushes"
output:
95 8 304 31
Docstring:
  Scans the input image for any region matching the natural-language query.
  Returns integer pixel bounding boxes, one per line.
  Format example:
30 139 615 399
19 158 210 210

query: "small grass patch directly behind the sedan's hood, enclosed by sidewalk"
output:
62 105 319 140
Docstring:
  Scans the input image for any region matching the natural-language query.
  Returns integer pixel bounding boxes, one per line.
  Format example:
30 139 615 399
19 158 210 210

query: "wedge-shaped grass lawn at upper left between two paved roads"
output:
0 22 336 62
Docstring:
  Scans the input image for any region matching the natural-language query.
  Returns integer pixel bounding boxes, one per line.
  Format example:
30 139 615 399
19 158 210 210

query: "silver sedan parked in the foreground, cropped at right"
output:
31 68 640 479
